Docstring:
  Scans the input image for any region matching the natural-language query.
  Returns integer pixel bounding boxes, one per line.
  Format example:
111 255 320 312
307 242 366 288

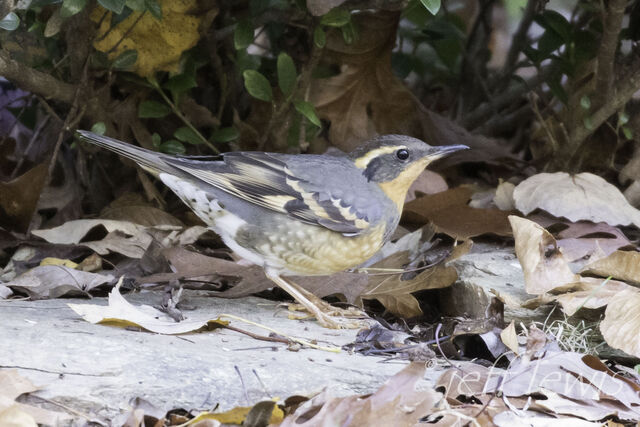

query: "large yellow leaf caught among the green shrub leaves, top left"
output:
91 0 202 77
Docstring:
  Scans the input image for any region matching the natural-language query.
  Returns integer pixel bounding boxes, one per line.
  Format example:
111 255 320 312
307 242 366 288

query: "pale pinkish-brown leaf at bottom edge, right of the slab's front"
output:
280 362 442 427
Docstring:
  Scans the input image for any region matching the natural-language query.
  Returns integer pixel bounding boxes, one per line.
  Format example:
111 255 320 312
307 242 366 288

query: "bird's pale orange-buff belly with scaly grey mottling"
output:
236 220 384 275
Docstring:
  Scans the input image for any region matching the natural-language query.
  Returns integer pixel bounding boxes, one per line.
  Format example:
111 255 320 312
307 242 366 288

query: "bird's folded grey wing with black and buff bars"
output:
165 152 381 235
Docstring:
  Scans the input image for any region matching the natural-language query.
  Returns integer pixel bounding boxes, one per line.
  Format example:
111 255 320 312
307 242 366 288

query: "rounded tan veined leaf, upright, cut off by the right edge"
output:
600 289 640 357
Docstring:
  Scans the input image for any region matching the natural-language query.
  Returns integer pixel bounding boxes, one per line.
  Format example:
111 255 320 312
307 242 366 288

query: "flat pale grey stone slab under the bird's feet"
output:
0 291 439 420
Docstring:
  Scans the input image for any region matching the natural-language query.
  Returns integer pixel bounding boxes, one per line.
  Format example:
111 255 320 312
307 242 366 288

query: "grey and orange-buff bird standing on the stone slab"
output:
78 130 469 328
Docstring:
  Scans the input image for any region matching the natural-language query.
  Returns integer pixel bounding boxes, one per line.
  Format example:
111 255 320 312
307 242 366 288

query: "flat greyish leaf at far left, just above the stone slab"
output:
5 265 115 300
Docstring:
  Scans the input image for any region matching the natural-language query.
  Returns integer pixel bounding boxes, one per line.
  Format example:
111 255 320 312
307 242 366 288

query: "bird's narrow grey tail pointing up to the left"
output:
77 130 178 175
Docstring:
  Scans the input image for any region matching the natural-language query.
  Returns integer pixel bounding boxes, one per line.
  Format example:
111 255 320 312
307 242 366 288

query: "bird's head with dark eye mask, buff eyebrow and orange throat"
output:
349 135 469 209
